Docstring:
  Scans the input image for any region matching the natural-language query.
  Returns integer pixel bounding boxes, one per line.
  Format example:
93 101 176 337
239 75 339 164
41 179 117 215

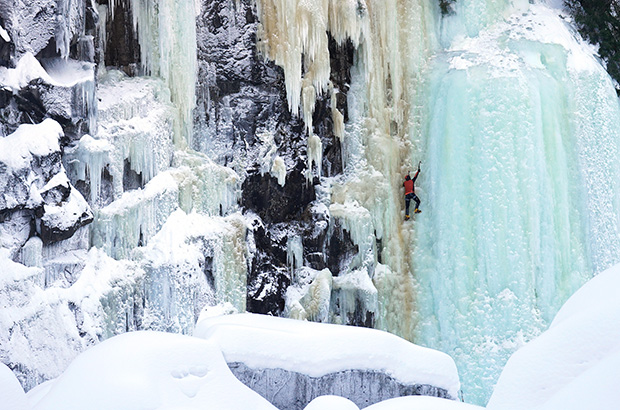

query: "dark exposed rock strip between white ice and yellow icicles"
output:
195 0 353 315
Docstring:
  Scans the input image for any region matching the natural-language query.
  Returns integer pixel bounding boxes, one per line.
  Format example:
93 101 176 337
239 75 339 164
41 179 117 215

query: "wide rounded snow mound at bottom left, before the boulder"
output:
28 332 276 410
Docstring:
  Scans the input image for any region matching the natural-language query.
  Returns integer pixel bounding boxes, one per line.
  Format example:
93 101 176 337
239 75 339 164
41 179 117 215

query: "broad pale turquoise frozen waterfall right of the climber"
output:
411 1 620 403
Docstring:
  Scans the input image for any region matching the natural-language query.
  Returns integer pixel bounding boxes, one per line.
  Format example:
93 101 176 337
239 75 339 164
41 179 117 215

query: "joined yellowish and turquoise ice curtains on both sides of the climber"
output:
254 0 620 403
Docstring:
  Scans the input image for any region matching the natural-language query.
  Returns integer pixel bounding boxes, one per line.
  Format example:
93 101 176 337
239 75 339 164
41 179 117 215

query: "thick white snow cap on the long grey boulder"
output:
194 313 460 397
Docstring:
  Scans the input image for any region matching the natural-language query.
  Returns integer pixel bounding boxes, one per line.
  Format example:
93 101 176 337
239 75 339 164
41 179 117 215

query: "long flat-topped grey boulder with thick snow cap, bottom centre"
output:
194 314 460 409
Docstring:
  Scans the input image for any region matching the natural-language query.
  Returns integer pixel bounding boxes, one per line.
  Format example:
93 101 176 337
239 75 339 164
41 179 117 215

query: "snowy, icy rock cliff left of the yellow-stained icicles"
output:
0 0 376 388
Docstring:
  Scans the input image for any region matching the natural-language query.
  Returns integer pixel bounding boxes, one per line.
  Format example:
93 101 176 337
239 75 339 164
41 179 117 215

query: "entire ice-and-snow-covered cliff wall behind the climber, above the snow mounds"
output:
0 0 620 403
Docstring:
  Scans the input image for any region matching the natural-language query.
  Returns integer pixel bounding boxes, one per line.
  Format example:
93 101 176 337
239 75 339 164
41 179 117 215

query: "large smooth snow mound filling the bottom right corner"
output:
488 265 620 410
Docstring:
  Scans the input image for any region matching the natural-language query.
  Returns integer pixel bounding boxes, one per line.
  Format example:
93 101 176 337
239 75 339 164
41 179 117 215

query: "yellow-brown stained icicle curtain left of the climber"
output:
258 0 437 338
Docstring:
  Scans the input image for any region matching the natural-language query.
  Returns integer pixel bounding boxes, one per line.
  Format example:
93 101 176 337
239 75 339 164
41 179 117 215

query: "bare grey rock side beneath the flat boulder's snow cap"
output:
228 363 454 410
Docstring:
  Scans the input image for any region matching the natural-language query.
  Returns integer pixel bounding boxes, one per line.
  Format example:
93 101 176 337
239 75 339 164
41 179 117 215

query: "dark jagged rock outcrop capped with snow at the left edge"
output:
0 119 93 253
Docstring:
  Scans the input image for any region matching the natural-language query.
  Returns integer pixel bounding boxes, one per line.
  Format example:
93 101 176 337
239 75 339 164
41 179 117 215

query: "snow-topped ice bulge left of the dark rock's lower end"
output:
134 210 247 326
